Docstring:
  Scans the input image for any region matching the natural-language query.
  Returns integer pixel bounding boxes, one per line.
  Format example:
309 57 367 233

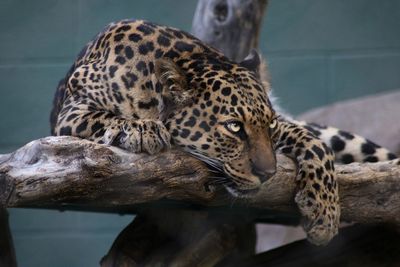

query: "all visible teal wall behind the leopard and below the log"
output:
0 0 400 267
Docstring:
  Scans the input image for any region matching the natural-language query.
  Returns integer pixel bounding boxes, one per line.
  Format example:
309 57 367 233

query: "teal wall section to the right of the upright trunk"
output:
261 0 400 113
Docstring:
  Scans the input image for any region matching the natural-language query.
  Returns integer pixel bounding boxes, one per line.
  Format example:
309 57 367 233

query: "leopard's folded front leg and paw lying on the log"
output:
55 100 171 154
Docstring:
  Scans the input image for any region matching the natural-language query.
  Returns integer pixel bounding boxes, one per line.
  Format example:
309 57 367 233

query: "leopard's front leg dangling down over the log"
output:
272 120 340 245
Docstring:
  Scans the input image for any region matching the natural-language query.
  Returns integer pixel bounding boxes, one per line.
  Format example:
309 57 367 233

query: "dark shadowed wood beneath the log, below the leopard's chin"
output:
101 209 256 267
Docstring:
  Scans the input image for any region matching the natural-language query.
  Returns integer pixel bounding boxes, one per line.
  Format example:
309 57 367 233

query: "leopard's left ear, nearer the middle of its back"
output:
155 58 187 91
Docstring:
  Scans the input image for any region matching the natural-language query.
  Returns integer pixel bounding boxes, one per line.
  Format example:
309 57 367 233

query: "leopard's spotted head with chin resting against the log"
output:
156 52 276 196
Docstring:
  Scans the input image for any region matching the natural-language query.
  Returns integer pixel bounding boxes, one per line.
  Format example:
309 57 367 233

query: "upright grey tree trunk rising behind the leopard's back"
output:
192 0 268 62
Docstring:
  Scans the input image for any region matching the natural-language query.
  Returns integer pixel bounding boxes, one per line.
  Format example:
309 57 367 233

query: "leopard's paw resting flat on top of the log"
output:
103 120 171 154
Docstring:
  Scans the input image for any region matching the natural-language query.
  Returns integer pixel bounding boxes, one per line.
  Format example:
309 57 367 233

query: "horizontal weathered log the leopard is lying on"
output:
0 137 400 224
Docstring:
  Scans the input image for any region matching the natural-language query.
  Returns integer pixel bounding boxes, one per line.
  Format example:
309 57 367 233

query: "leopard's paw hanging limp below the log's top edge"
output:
295 188 340 246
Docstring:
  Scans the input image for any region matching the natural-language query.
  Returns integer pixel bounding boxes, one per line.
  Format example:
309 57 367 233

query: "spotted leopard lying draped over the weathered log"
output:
50 19 394 245
